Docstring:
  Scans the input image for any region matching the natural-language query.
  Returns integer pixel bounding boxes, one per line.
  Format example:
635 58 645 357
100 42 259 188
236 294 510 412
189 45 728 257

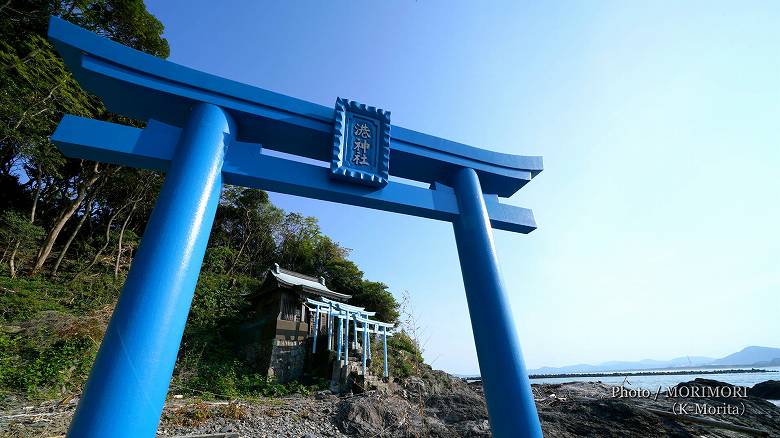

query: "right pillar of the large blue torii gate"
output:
452 169 542 437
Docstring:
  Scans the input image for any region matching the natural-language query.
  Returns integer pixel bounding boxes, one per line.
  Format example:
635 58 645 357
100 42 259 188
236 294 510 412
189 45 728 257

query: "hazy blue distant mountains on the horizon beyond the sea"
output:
530 347 780 374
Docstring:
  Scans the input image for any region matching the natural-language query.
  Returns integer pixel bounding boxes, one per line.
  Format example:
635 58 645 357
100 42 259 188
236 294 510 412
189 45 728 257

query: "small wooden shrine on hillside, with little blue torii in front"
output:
240 263 393 390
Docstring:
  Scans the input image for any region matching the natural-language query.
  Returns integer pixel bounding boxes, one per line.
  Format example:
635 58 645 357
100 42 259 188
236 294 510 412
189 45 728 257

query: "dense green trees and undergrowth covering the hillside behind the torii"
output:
0 0 408 397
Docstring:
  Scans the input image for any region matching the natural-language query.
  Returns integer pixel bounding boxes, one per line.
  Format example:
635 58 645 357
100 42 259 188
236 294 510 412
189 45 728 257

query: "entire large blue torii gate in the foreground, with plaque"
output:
49 17 542 437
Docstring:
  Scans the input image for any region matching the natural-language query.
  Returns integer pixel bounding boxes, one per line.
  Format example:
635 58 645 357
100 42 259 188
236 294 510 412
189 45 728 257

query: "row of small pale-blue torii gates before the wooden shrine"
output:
306 297 394 377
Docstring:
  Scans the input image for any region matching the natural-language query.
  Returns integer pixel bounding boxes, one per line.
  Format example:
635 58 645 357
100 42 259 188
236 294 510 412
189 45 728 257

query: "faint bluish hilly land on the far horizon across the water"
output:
529 346 780 377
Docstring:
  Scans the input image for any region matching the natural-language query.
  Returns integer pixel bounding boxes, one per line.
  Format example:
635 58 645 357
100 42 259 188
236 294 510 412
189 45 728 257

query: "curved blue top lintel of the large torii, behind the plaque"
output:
49 17 542 197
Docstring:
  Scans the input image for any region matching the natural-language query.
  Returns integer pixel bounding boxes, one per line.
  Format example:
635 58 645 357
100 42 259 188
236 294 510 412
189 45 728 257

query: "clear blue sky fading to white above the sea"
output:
147 0 780 374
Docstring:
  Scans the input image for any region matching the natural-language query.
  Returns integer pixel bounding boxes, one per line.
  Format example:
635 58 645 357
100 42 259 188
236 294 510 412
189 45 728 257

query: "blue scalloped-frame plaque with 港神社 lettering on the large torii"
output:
330 97 390 187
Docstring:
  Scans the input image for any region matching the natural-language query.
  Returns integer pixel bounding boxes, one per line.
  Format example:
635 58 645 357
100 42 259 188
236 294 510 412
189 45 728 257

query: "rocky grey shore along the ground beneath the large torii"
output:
0 370 780 438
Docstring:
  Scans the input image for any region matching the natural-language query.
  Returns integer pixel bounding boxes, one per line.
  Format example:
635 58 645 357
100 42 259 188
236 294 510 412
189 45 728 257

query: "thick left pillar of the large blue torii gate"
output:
68 103 235 437
